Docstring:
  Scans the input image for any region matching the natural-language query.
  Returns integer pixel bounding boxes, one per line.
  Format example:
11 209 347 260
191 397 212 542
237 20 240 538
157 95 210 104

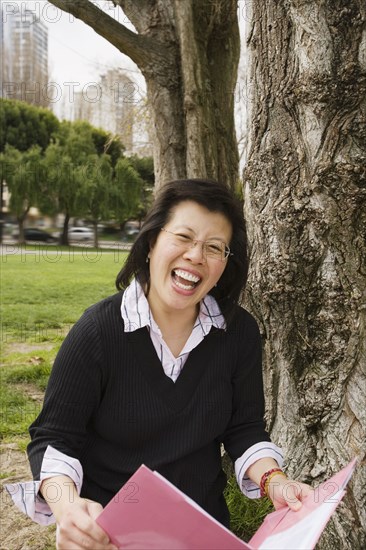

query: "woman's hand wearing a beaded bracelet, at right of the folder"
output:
267 475 313 511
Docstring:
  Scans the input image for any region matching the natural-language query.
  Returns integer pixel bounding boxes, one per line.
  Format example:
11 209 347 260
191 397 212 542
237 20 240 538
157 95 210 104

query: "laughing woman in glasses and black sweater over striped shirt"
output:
7 180 310 549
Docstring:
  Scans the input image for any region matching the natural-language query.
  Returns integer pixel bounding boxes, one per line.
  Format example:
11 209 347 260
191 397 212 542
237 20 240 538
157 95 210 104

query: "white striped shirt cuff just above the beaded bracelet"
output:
235 441 284 498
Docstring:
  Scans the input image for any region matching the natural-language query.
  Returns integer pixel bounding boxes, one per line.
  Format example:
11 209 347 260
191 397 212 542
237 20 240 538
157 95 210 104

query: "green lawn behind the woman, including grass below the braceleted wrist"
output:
0 246 271 540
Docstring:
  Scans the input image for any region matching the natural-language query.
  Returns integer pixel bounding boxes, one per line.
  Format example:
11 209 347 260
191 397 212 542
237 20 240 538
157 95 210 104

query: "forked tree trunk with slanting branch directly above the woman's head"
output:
51 0 240 187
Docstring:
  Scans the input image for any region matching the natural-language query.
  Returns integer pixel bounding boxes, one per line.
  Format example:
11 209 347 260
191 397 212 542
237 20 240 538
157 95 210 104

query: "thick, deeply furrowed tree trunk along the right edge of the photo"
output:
244 0 366 550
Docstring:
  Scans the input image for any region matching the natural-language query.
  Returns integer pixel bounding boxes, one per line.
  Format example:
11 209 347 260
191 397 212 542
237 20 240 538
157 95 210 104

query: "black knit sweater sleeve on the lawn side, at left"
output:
28 310 103 479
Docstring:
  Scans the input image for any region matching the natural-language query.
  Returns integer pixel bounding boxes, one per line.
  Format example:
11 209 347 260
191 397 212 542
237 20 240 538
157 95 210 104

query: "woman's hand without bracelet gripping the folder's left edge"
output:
56 497 117 550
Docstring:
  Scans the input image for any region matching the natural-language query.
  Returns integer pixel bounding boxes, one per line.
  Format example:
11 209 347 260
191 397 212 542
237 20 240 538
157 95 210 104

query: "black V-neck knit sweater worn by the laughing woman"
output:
28 293 269 525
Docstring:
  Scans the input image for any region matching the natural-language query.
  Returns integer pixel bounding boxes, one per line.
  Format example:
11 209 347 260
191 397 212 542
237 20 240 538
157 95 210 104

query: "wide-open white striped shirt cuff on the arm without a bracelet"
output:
5 445 83 525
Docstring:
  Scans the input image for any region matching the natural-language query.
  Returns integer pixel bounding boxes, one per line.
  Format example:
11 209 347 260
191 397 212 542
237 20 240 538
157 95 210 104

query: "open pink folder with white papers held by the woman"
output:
97 459 356 550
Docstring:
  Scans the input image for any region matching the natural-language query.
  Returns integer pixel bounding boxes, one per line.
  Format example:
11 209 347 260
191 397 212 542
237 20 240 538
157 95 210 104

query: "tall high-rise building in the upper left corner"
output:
0 2 49 107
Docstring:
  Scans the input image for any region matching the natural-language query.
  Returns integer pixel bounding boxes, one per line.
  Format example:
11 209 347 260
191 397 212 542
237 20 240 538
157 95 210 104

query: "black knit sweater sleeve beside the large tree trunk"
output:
222 309 270 461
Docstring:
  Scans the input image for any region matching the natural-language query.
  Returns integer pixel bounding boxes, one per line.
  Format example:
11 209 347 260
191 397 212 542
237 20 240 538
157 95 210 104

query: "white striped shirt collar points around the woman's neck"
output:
121 279 226 336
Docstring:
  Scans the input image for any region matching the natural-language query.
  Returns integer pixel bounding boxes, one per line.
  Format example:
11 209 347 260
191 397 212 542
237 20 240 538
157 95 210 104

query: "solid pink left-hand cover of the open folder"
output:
97 466 250 550
